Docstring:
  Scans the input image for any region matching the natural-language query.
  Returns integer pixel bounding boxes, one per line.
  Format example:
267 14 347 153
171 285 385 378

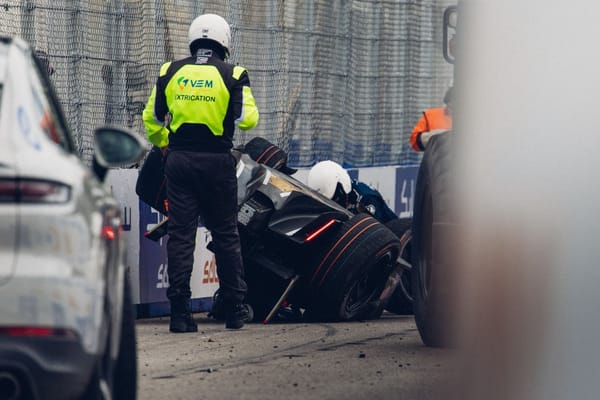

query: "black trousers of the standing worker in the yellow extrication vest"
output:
165 150 247 303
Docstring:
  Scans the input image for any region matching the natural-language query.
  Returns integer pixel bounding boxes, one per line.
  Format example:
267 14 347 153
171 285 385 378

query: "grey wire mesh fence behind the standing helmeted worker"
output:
0 0 452 166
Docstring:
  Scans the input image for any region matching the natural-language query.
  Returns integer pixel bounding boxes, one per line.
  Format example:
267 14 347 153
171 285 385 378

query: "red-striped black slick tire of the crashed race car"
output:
307 214 400 321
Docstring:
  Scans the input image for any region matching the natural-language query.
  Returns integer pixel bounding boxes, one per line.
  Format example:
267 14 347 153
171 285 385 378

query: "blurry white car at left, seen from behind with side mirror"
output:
0 38 146 399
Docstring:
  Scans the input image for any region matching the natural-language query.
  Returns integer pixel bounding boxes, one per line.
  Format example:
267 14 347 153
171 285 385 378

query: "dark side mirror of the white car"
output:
93 126 147 180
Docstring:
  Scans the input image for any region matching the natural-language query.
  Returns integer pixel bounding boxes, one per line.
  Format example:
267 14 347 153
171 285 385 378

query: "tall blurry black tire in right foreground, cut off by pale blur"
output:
411 132 457 347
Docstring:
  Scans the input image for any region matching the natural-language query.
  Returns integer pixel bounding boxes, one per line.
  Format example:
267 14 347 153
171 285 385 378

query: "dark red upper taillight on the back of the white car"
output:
0 179 71 204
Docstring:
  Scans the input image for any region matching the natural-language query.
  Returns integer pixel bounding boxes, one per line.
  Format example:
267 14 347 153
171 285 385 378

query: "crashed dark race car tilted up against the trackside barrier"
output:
136 138 402 323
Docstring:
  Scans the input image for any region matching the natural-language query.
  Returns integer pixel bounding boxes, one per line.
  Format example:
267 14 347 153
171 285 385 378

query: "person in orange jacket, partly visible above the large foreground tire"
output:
410 87 454 151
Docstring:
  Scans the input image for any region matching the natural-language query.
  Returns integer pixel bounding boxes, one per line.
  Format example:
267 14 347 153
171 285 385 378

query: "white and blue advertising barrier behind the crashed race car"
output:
108 166 418 317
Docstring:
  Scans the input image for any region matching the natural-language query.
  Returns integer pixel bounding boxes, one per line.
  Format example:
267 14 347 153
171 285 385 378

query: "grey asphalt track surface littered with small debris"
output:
137 313 454 400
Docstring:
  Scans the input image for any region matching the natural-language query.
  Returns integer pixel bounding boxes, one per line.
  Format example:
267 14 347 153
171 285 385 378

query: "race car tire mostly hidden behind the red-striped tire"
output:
385 218 413 315
